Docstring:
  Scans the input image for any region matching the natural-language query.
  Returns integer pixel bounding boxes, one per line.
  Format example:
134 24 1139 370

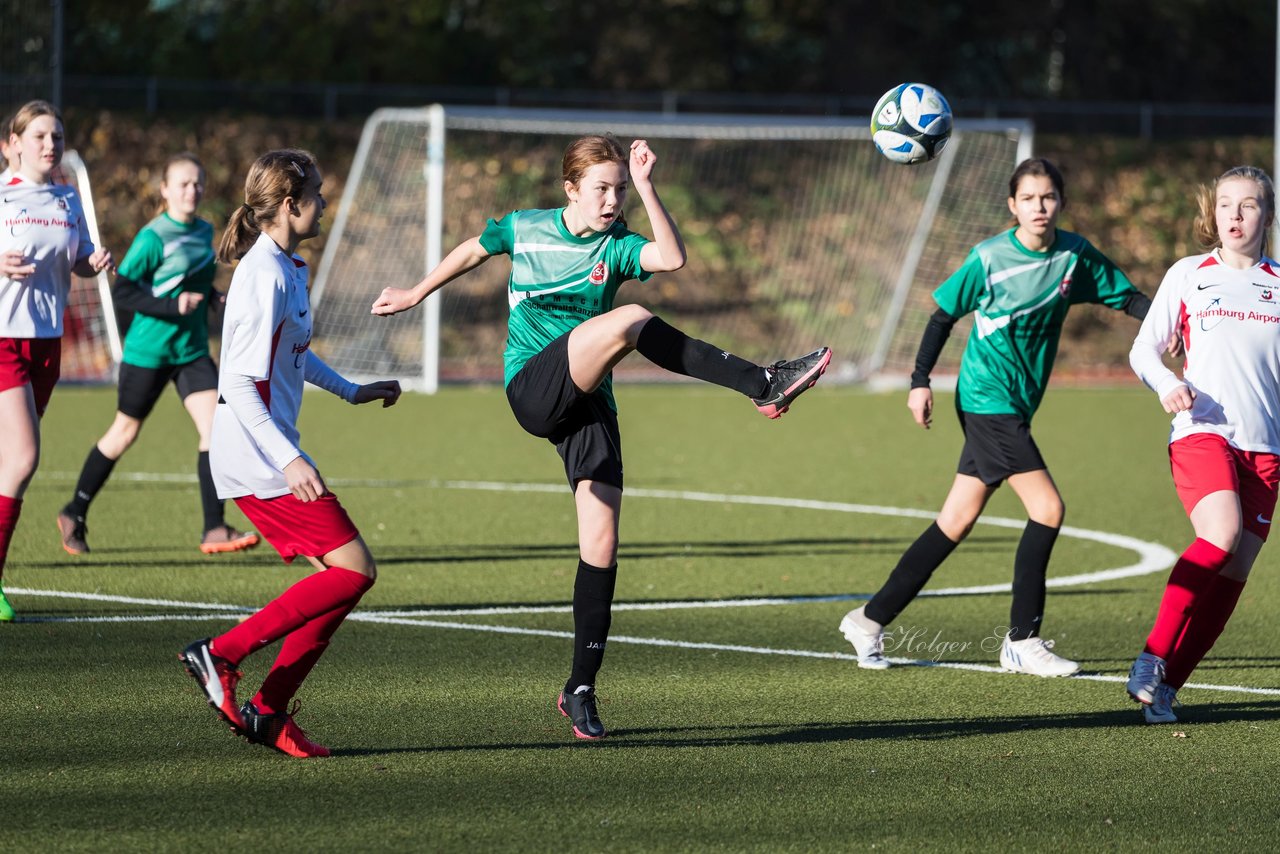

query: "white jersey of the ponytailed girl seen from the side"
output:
209 234 320 498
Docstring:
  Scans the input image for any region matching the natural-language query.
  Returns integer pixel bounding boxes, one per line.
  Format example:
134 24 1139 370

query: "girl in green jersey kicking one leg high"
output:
372 136 831 739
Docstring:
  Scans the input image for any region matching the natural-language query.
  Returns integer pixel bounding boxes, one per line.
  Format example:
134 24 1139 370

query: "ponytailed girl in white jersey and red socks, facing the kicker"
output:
179 150 401 758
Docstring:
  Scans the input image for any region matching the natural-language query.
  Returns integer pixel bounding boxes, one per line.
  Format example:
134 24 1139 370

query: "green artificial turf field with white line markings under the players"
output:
0 385 1280 851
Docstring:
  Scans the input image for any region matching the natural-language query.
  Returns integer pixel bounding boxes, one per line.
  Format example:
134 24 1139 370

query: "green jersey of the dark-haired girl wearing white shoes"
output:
933 229 1138 423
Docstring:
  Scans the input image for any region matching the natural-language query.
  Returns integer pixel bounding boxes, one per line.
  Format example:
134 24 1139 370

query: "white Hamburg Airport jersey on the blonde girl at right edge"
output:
1129 250 1280 453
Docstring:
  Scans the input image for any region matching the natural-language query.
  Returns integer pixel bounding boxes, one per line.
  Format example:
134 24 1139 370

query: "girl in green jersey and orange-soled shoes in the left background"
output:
58 154 257 554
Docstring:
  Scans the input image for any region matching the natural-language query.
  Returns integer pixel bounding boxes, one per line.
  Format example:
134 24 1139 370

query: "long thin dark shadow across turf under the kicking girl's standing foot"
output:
334 700 1280 757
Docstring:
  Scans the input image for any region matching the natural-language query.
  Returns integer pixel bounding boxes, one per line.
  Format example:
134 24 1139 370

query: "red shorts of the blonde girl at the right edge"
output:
1169 433 1280 540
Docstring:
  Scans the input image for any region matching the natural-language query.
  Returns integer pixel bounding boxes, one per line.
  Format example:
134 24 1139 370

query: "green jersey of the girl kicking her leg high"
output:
480 207 650 410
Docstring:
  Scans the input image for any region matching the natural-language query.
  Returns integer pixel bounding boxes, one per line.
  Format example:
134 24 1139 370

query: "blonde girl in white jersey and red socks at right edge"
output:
1126 166 1280 723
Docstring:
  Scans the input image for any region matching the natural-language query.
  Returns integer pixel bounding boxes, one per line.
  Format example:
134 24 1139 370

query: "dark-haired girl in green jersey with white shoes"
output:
840 157 1151 676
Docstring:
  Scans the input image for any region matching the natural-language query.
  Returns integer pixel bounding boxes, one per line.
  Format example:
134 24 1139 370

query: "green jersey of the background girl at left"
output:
119 214 215 367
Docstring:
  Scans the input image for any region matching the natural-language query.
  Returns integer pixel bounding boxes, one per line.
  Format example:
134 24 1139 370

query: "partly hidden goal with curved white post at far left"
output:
58 151 120 383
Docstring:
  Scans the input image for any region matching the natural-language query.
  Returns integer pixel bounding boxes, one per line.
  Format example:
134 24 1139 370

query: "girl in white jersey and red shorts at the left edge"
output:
0 101 111 621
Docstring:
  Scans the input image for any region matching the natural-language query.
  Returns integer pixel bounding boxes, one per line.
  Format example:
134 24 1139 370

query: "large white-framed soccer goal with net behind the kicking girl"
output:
312 105 1032 391
